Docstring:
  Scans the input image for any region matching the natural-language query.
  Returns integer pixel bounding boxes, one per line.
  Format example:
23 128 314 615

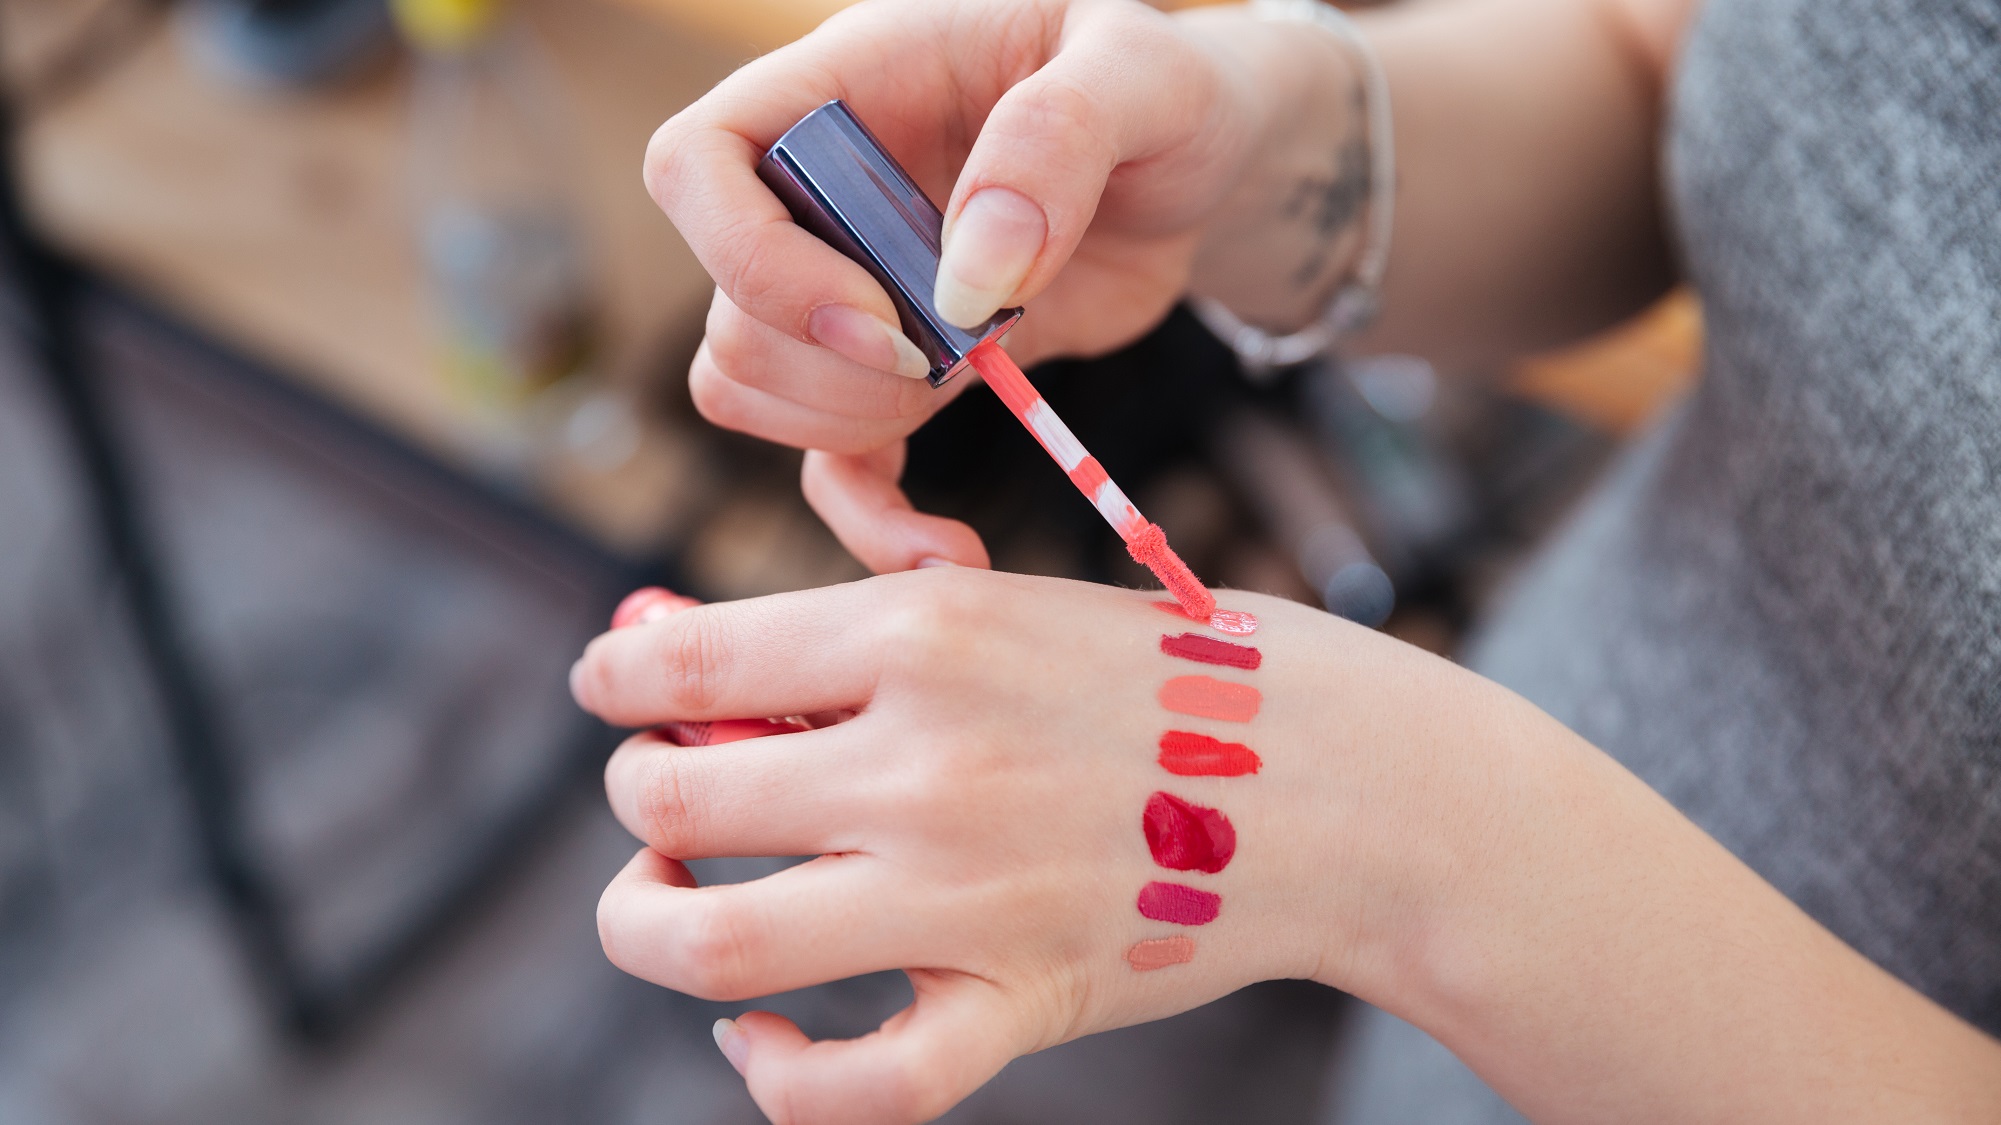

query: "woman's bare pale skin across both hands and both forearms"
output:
572 0 2001 1125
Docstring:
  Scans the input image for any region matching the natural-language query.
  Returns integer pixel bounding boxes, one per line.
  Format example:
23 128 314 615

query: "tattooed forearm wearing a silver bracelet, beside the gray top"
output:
1185 0 1689 368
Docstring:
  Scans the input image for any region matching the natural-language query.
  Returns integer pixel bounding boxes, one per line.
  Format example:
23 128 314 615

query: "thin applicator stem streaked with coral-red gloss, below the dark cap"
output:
966 340 1217 621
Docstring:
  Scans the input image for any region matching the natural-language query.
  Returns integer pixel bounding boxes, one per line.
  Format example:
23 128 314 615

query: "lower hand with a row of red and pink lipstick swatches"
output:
572 569 1483 1125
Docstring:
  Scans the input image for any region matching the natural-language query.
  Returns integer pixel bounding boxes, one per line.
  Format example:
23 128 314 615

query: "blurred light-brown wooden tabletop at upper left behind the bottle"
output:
6 0 738 548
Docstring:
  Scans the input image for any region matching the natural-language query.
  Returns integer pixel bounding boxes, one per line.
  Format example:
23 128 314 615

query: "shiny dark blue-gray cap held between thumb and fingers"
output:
756 100 1021 386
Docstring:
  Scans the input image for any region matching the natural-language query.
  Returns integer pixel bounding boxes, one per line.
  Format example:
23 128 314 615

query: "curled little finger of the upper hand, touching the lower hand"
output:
798 442 992 575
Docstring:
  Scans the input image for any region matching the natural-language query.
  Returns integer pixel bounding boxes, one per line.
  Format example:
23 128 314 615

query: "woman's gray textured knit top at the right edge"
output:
1333 0 2001 1125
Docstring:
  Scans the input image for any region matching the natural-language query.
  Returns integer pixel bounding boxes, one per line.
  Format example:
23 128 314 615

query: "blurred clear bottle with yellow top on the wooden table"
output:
394 0 596 468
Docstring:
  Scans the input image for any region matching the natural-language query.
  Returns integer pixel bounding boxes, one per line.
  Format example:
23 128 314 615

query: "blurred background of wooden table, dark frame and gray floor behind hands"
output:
0 0 1699 1125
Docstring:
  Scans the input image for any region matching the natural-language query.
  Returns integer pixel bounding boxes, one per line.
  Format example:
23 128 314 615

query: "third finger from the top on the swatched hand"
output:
598 849 928 1001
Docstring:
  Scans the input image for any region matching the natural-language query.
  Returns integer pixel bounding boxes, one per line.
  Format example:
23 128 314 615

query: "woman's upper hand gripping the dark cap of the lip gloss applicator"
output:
646 0 1320 571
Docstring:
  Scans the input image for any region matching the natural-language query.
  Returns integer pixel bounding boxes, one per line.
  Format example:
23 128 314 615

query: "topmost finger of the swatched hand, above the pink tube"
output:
570 583 880 727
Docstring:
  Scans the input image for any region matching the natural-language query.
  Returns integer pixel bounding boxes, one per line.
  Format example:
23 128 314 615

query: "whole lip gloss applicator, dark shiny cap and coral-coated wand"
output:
756 100 1217 621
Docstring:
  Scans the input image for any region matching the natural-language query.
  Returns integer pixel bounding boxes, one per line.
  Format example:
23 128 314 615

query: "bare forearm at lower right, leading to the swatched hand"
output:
1351 668 2001 1123
